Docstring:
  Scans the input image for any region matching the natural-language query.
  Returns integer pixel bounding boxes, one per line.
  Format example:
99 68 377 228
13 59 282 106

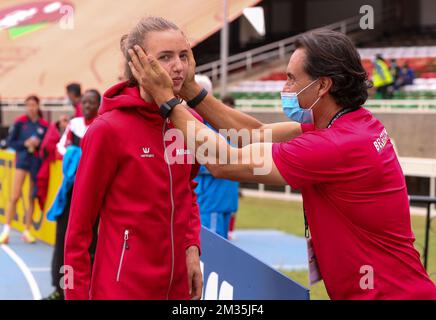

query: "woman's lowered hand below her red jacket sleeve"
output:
186 246 203 300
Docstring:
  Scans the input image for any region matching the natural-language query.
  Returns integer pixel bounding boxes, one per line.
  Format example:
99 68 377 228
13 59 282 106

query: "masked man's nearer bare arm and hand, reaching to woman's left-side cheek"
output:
129 46 287 185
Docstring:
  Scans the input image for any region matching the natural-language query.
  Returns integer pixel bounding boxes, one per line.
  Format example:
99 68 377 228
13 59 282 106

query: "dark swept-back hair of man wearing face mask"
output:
295 29 371 108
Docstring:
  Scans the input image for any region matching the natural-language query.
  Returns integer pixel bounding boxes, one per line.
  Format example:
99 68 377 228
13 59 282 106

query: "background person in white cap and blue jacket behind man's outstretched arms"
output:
195 75 239 239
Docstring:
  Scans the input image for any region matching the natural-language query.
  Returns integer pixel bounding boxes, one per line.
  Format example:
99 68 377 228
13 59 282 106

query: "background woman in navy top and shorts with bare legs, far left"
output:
0 95 49 244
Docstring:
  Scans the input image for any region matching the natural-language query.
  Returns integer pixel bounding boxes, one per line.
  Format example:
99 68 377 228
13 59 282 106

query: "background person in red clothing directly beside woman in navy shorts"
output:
36 115 68 211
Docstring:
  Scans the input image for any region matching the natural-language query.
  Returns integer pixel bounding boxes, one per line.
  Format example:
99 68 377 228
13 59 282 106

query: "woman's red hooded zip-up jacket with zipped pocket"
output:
64 83 201 299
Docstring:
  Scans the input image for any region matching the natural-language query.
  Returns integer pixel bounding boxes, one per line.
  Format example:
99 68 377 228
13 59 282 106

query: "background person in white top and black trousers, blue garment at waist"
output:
45 90 101 300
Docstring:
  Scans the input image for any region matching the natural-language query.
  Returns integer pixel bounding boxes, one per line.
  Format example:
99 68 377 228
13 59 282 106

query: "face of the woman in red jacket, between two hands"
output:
145 30 189 94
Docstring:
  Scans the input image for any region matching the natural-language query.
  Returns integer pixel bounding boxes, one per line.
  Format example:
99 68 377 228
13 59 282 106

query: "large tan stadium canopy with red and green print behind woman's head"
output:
0 0 260 98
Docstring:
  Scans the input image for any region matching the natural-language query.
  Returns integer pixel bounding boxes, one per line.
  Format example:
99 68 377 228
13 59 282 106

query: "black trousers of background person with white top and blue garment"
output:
51 188 99 292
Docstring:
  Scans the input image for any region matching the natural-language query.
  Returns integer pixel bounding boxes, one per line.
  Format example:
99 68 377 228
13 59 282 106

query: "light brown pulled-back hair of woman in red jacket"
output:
120 16 183 86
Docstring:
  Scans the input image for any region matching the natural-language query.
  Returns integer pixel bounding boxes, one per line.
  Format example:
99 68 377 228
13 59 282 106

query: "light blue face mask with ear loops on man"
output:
281 79 321 123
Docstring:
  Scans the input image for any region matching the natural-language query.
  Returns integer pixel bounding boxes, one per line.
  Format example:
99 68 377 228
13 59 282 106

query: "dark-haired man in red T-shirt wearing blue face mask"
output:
130 30 436 299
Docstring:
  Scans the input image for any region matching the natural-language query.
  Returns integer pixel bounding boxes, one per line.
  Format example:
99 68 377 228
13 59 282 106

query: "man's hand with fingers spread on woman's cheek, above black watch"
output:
129 45 174 105
